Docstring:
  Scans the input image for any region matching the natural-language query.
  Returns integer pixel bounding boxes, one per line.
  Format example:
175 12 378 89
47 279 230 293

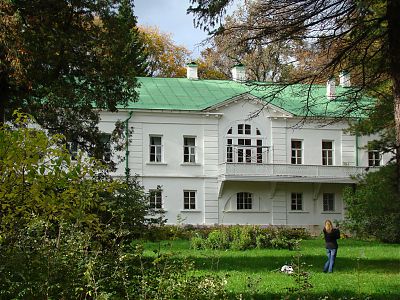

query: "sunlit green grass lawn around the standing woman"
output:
145 239 400 299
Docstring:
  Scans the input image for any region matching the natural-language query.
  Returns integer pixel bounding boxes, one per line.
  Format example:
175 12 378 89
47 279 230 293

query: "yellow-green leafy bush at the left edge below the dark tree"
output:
0 111 117 236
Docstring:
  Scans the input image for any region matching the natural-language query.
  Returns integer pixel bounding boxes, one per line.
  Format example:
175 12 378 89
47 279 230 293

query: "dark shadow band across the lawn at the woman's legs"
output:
191 252 400 274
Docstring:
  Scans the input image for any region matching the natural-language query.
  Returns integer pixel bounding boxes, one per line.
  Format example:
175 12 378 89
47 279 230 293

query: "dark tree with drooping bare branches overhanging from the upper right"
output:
188 0 400 192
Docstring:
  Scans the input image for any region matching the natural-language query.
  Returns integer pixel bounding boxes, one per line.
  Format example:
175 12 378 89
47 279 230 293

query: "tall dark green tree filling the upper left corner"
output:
0 0 145 159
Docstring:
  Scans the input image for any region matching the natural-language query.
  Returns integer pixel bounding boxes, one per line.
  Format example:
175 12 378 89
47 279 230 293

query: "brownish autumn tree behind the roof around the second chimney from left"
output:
202 1 297 81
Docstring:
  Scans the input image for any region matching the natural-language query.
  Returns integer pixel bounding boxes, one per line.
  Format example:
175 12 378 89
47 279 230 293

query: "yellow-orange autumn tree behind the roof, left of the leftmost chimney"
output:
139 26 190 77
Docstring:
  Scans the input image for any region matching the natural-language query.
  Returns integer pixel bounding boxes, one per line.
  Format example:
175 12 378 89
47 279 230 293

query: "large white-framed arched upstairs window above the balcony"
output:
226 123 268 163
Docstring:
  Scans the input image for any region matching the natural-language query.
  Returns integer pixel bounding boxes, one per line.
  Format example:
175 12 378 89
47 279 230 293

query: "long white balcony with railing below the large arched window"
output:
219 163 370 183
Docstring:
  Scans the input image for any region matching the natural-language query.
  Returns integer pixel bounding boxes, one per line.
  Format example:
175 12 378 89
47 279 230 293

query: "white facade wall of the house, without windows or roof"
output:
100 97 389 226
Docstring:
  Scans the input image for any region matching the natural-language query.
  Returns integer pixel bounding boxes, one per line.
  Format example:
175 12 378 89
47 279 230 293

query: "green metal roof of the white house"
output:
120 77 371 117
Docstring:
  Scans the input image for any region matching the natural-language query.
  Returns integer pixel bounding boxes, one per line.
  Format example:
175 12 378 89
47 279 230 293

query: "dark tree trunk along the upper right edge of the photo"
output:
386 0 400 195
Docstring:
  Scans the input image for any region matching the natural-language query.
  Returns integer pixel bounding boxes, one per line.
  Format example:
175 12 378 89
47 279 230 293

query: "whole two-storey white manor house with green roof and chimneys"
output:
99 64 390 229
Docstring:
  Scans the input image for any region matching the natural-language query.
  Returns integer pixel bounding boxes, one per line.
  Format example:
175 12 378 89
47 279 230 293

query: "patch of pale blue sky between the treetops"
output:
134 0 241 58
